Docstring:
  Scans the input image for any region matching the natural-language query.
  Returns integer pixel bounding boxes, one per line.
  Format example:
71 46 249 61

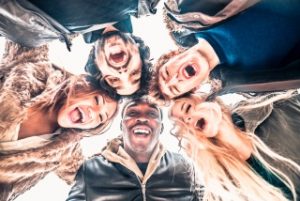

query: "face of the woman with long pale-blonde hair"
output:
170 96 222 137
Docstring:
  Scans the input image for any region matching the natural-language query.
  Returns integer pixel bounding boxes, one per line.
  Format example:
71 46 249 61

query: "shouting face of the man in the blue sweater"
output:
158 47 210 98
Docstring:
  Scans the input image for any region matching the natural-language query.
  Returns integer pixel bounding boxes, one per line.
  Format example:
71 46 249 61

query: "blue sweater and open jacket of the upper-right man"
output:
165 0 300 93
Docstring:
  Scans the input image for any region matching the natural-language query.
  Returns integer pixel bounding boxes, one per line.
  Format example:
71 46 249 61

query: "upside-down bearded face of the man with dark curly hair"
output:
96 32 142 95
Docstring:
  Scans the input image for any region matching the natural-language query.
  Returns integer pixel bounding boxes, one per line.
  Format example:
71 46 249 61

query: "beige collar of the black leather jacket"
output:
101 137 166 184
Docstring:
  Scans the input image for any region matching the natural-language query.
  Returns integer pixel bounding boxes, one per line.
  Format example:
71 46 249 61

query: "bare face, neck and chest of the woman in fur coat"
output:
18 93 117 139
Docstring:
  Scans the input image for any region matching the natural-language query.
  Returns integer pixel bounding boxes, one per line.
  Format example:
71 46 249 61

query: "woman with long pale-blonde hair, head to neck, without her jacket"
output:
170 94 299 201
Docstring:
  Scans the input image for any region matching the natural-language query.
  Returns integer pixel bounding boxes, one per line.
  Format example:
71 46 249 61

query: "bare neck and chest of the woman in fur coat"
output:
18 108 59 139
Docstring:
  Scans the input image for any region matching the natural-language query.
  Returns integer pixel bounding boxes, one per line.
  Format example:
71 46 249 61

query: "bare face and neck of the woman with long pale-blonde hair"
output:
170 95 253 160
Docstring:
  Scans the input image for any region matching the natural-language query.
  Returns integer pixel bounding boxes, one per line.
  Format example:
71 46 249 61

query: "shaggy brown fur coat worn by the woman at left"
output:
0 42 102 201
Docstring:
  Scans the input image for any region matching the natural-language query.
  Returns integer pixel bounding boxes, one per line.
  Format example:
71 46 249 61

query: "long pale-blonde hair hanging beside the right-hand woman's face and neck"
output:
170 95 300 201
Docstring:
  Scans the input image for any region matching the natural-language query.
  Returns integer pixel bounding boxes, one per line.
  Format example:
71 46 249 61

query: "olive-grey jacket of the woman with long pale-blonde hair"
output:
233 94 300 196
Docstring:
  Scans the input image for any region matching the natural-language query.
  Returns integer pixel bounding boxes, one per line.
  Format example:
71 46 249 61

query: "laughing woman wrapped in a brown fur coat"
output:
0 42 117 201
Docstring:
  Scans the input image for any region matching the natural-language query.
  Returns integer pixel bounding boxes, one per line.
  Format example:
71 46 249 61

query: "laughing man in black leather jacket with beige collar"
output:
67 98 201 201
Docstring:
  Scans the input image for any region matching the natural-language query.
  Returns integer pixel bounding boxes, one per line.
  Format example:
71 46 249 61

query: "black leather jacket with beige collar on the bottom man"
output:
67 140 200 201
